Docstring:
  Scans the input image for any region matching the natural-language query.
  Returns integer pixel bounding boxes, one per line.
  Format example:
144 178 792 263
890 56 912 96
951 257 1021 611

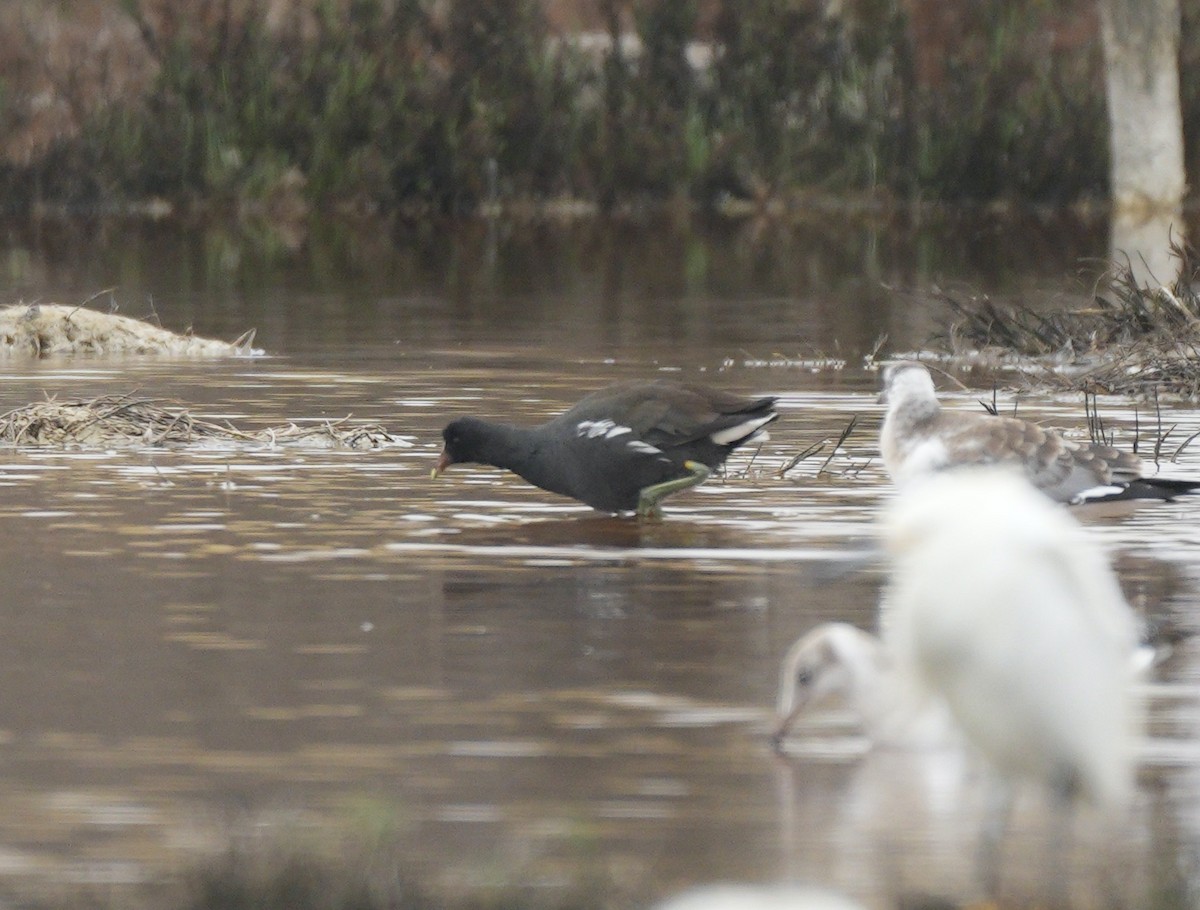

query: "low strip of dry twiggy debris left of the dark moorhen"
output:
0 395 412 449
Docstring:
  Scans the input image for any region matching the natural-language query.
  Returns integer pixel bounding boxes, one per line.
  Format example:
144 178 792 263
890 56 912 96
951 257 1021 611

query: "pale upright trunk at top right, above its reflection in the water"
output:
1098 0 1184 215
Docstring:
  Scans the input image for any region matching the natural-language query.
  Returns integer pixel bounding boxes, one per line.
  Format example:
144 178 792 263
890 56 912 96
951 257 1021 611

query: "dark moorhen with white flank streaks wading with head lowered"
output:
433 382 779 515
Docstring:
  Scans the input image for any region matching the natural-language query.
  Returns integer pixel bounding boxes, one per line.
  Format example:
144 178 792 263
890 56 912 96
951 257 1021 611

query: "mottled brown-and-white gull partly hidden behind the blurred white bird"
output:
880 361 1200 503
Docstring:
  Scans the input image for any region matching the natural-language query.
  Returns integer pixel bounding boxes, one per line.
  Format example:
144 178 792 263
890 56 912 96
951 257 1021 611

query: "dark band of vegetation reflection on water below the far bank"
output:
0 211 1108 362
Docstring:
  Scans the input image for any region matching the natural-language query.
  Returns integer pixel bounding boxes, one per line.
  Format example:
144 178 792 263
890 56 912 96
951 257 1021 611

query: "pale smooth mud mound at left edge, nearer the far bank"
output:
0 301 263 357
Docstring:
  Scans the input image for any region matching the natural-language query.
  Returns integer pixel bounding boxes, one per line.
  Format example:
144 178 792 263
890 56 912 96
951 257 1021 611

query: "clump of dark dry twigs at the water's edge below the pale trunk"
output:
947 244 1200 401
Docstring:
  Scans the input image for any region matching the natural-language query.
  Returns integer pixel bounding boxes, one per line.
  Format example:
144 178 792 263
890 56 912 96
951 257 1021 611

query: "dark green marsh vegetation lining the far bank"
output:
5 0 1106 220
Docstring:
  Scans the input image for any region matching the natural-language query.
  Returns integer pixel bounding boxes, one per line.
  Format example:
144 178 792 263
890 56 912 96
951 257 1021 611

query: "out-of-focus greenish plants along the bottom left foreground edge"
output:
5 795 628 910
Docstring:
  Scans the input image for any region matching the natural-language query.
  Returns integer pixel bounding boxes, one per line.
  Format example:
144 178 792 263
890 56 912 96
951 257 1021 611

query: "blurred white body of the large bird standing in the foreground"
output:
882 468 1138 809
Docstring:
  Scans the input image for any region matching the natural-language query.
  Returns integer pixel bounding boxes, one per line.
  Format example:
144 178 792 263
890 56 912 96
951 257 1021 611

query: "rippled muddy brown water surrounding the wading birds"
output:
0 217 1200 906
